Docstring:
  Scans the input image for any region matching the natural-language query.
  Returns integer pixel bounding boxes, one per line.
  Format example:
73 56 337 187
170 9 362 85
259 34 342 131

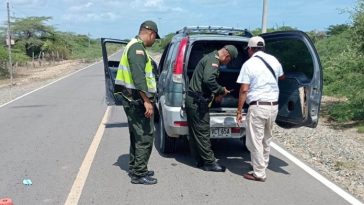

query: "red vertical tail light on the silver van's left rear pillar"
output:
173 37 188 83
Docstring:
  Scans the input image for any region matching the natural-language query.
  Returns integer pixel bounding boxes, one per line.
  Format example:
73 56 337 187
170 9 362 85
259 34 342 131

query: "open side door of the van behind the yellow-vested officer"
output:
101 38 128 105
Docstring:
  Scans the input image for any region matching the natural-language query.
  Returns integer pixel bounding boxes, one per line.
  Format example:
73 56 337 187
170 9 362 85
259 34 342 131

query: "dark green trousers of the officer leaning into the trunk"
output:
186 95 215 164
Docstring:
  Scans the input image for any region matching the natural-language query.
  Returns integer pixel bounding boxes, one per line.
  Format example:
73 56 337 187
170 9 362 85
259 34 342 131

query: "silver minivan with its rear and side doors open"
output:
102 27 323 153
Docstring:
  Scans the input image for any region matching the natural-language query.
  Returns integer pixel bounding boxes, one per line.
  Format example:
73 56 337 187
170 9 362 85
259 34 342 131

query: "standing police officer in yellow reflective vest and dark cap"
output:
115 21 159 184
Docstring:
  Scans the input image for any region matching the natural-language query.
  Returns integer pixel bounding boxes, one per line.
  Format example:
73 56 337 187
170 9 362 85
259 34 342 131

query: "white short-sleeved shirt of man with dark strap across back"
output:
236 51 283 104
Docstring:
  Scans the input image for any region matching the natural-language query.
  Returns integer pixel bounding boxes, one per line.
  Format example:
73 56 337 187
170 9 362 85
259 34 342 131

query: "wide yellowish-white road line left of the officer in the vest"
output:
64 106 111 205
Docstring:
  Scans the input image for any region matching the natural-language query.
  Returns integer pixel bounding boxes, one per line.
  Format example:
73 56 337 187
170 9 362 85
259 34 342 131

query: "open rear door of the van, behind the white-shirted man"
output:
261 31 323 128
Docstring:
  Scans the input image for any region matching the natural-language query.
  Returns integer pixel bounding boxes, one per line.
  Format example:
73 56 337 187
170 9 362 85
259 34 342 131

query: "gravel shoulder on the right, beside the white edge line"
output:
274 119 364 201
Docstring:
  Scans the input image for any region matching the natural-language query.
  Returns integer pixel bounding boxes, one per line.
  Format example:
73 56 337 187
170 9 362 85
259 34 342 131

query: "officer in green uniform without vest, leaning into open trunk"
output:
186 45 238 172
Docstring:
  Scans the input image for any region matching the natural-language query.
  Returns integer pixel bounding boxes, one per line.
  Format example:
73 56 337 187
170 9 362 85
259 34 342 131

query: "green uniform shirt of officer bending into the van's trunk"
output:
189 51 224 97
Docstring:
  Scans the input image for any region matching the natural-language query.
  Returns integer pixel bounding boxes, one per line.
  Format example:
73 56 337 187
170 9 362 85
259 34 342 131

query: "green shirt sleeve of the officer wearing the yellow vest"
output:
128 36 149 99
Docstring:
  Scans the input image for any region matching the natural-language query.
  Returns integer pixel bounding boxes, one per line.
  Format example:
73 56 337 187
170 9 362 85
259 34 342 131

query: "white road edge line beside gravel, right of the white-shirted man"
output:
271 142 363 205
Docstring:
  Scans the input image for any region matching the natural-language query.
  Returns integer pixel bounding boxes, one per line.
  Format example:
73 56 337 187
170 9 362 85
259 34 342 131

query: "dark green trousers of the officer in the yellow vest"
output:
123 100 154 176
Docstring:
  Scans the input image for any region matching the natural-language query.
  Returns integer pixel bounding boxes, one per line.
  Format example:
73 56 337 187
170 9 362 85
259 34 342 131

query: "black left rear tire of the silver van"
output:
158 109 176 154
